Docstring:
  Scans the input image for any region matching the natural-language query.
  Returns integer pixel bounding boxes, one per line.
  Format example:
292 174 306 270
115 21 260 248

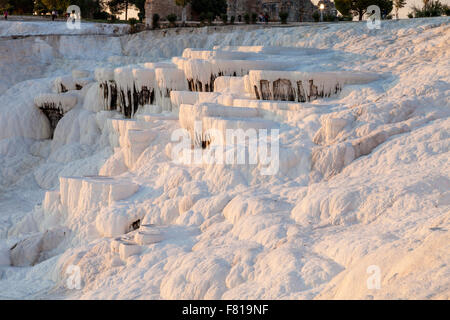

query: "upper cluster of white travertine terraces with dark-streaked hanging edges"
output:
89 46 378 117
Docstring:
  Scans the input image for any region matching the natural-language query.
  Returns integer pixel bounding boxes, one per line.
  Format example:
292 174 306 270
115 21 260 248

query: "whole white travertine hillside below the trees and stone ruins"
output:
5 18 450 299
